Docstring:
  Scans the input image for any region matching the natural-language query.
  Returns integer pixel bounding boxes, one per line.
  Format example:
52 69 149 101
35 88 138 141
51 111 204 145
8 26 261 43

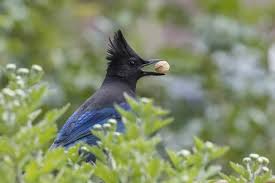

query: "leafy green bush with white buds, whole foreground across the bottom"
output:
0 64 271 183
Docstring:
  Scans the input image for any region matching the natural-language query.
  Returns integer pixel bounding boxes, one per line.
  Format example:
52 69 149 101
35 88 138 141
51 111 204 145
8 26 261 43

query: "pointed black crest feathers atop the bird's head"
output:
106 30 139 62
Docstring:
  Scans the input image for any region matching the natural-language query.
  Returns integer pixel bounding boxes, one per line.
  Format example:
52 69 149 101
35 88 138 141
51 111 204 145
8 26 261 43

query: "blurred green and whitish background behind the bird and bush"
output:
0 0 275 168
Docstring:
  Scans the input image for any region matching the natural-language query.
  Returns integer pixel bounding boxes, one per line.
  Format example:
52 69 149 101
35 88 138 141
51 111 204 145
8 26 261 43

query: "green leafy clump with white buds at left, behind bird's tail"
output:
0 64 93 182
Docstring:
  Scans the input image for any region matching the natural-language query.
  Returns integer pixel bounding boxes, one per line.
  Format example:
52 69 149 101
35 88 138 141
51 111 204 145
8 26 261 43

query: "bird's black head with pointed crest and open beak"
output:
106 30 163 81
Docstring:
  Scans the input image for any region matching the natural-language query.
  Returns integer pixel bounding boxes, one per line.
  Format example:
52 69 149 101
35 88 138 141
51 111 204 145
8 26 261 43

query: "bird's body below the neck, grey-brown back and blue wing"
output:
51 78 135 148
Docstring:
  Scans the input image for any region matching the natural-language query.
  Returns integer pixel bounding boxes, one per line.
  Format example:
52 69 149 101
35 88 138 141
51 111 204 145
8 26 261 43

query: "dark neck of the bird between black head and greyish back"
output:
101 75 137 97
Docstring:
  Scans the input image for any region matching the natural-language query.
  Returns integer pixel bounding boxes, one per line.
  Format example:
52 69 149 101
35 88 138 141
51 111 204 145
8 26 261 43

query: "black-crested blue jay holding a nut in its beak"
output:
50 30 165 159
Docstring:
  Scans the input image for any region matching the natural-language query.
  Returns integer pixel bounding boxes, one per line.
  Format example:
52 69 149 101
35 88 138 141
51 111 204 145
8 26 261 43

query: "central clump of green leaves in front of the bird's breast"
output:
87 97 227 182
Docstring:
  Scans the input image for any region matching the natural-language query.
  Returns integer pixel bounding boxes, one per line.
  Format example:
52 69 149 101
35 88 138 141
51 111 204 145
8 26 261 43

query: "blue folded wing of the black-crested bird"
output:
52 103 130 148
